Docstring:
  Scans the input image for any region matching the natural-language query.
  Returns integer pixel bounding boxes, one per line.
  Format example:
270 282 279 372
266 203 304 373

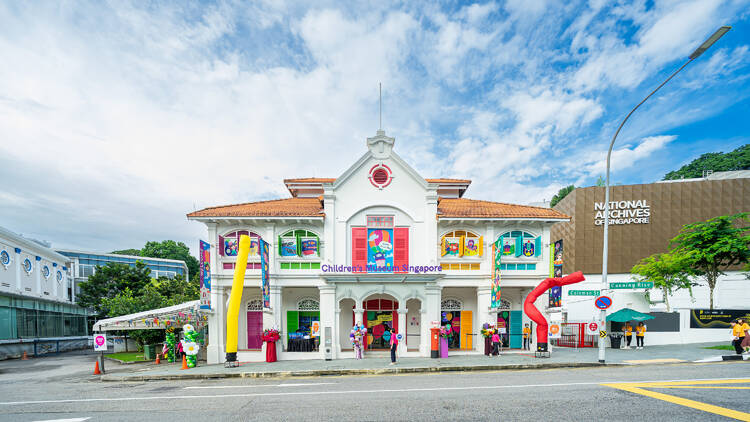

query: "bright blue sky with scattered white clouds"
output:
0 0 750 252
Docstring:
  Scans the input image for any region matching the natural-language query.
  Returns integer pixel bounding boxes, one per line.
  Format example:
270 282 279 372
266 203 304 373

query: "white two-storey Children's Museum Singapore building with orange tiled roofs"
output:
188 131 569 363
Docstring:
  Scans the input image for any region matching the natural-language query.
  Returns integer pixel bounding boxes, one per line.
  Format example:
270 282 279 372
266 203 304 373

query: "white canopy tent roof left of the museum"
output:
94 300 208 332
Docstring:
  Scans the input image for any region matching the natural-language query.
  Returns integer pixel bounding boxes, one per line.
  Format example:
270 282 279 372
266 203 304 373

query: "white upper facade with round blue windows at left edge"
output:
0 227 72 303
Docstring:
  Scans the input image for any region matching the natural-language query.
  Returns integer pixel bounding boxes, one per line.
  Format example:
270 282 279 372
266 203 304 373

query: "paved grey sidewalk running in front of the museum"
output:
101 343 748 381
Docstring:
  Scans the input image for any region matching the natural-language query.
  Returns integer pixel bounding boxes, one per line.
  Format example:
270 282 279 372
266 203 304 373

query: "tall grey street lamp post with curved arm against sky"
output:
599 26 732 363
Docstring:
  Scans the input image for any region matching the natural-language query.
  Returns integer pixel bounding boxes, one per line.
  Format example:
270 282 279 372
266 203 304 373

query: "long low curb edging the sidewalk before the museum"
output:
100 362 622 381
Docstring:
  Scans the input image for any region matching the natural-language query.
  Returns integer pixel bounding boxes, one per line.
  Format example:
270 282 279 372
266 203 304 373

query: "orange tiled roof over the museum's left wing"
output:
187 198 325 217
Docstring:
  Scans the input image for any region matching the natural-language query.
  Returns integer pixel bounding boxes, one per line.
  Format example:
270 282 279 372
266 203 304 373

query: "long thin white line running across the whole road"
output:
0 378 750 406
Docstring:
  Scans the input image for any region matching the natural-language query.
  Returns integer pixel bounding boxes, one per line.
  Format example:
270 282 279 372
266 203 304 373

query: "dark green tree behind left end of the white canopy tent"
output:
76 261 151 318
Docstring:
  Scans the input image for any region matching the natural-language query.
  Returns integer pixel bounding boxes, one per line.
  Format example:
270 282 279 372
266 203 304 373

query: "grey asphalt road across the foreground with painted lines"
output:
0 356 750 422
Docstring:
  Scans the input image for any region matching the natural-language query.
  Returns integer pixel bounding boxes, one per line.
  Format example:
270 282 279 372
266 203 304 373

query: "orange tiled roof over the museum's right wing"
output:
438 198 570 219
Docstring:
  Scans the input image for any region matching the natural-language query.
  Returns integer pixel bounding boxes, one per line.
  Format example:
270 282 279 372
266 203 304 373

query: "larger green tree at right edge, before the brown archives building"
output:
672 213 750 309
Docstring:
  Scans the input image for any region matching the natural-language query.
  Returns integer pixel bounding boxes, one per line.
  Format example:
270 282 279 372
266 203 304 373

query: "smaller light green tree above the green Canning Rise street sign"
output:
630 252 697 312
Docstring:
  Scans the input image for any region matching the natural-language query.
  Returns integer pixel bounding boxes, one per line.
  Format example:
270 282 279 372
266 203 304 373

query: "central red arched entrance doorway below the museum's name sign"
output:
362 295 398 350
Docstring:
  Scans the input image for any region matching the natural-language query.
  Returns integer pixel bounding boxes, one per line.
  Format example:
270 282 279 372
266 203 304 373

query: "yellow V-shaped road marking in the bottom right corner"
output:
602 378 750 422
